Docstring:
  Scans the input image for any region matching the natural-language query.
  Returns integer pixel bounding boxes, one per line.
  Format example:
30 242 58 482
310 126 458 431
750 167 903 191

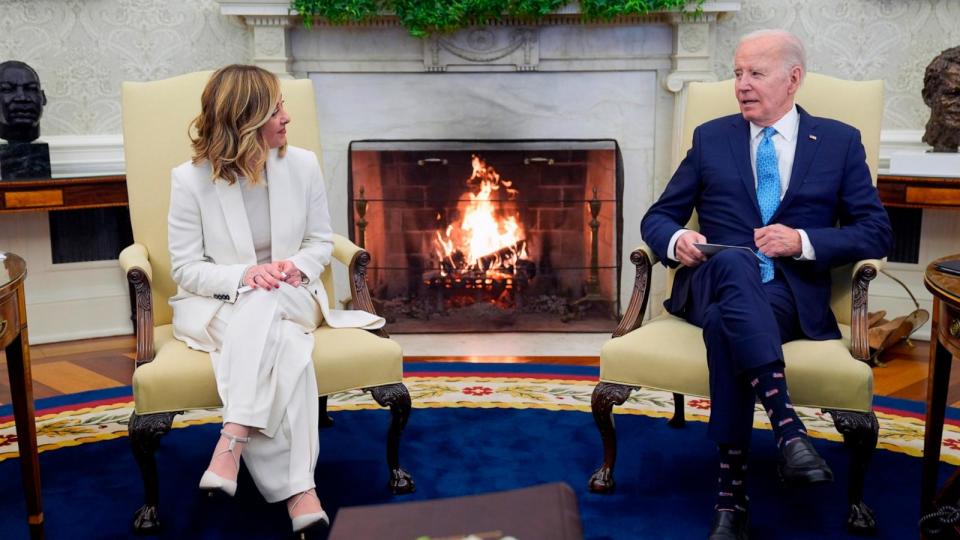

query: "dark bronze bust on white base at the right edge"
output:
922 47 960 152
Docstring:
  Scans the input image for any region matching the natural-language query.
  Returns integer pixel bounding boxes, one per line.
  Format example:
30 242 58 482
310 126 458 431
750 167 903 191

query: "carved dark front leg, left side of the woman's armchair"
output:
127 412 179 534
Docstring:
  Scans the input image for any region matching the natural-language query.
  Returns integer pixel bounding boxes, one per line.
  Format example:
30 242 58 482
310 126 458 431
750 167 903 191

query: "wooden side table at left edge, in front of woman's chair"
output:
0 252 43 539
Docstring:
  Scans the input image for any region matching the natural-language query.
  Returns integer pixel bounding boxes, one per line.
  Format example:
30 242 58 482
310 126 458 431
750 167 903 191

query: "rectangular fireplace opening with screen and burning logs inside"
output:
349 140 623 333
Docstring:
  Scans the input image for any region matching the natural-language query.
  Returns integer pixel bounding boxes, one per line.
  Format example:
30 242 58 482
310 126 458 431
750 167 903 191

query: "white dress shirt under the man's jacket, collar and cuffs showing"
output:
667 105 816 261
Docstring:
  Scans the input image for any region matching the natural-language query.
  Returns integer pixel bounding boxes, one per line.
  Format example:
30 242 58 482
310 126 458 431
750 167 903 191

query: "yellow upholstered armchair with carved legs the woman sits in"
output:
120 72 414 533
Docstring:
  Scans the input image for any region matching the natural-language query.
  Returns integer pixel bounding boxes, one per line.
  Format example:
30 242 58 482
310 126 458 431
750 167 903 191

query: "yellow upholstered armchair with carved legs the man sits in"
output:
590 73 883 533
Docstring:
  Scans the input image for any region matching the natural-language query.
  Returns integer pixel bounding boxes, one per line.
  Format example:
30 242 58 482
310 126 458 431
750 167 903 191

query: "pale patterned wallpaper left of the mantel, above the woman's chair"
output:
0 0 252 135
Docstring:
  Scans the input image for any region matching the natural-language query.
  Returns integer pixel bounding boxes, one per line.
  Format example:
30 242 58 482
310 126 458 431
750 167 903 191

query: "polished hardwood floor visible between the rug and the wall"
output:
0 336 960 406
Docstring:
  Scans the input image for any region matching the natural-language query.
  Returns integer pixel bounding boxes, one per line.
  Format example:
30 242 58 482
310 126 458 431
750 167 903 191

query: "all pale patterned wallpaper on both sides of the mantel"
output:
0 0 960 135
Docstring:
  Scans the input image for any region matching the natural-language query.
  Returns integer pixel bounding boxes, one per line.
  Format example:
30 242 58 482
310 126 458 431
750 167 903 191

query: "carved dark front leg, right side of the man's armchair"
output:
826 410 880 534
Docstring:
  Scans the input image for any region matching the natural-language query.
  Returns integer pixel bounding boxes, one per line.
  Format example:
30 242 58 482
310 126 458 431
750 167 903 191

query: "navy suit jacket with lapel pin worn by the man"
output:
641 107 892 339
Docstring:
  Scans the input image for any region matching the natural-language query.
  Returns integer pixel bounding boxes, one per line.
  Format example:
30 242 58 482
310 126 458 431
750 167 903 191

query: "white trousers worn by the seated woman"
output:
208 283 322 502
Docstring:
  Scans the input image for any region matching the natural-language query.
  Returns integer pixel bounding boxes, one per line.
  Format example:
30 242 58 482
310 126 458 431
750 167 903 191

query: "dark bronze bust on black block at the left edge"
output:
0 60 47 143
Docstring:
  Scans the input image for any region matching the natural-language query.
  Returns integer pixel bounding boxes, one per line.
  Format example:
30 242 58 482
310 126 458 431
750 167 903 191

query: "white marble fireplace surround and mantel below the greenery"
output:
218 0 741 338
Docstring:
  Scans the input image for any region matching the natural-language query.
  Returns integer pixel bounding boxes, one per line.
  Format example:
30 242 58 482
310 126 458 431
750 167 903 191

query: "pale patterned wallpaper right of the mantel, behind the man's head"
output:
715 0 960 129
